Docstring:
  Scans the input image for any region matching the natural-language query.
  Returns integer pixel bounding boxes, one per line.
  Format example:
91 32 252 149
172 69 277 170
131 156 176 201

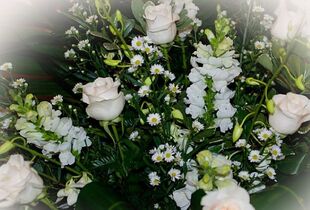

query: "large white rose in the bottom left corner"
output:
0 155 44 208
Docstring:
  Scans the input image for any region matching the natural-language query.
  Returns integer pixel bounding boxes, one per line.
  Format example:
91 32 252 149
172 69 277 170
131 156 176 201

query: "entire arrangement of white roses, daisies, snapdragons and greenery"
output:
0 0 310 210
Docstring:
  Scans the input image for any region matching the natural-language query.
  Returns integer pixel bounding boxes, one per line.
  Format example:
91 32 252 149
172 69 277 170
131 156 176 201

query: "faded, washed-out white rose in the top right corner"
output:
271 0 303 40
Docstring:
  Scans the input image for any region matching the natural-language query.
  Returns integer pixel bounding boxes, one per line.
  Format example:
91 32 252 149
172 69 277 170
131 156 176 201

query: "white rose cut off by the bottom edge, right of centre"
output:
201 185 254 210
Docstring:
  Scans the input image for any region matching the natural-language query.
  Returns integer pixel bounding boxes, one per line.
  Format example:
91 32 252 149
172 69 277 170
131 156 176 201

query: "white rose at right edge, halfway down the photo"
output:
269 93 310 135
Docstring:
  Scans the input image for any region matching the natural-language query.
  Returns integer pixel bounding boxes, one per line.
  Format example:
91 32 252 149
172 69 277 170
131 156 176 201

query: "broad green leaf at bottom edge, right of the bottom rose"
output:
251 184 304 210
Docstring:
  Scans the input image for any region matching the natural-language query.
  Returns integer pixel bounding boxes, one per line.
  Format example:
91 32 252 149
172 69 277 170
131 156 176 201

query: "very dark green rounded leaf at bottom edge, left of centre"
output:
76 182 131 210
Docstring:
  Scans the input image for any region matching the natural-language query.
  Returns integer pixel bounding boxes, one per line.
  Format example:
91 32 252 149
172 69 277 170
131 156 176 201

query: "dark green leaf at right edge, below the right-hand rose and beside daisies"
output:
278 153 308 175
